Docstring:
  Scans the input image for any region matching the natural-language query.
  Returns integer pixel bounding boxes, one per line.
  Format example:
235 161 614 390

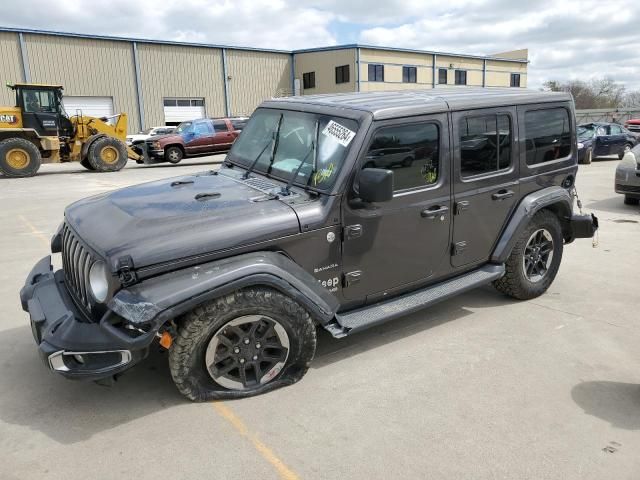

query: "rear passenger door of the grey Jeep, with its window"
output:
451 107 519 267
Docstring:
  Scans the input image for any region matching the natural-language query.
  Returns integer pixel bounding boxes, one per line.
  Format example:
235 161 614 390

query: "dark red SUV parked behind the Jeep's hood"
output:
145 117 248 163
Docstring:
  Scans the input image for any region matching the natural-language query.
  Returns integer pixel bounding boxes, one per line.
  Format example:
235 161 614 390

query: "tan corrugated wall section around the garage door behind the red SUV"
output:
138 43 225 127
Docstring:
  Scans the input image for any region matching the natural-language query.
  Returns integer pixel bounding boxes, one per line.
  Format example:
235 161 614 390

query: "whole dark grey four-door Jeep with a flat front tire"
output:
20 89 597 400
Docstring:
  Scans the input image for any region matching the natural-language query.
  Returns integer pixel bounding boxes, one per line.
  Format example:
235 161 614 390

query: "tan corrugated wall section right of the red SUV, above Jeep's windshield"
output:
226 50 292 115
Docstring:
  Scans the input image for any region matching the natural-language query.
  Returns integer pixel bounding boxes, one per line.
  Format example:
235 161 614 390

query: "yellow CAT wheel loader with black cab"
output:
0 83 144 177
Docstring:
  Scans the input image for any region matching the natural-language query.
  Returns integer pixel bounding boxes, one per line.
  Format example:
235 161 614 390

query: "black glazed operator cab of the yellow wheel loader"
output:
20 88 60 137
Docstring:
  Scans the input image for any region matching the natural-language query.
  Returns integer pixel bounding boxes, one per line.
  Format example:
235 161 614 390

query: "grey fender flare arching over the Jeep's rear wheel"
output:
491 186 573 263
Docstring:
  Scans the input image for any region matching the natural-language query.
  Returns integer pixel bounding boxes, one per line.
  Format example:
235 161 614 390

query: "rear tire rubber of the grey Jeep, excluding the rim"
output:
493 210 564 300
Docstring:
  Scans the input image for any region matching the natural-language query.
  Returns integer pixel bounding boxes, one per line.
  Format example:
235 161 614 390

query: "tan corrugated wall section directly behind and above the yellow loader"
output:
24 34 140 132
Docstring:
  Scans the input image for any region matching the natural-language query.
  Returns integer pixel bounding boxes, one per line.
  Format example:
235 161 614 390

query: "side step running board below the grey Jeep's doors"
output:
326 265 504 338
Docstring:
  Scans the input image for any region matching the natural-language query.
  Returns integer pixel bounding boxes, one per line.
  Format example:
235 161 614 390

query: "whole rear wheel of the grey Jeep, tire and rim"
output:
493 210 564 300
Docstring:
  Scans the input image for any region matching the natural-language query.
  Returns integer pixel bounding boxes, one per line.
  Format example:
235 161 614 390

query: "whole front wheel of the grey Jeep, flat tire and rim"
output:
169 287 316 401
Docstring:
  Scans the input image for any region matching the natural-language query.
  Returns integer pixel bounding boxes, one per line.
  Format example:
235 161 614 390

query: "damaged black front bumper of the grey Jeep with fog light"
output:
20 256 152 380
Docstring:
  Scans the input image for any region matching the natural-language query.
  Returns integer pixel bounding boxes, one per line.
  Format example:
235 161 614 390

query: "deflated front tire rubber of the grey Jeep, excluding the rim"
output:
169 287 316 401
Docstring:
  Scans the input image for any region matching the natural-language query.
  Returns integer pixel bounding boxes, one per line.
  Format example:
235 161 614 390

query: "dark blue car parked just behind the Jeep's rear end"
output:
578 122 638 164
